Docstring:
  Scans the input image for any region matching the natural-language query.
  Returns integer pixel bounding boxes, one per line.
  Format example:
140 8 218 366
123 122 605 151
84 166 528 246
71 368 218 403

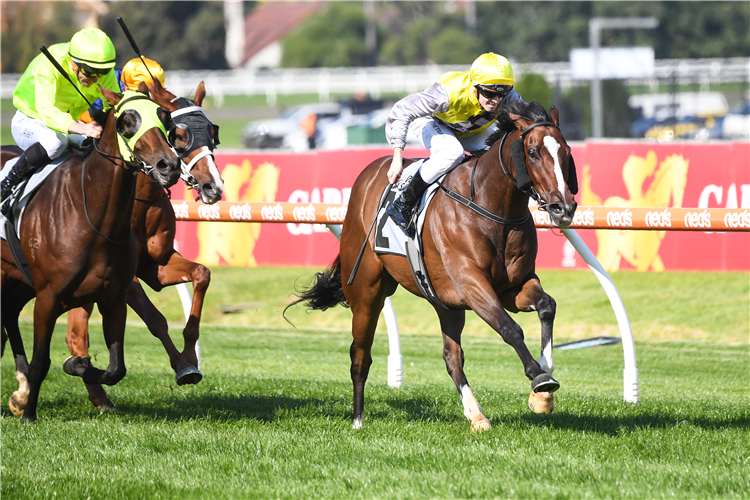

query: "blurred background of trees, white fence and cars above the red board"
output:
0 0 750 151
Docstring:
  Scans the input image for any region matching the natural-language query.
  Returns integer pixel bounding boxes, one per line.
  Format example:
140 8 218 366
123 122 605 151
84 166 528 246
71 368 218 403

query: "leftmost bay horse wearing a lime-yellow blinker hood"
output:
0 89 180 422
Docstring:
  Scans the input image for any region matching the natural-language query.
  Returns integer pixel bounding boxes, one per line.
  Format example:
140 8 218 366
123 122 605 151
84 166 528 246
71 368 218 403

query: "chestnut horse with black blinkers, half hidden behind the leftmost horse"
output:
65 82 224 409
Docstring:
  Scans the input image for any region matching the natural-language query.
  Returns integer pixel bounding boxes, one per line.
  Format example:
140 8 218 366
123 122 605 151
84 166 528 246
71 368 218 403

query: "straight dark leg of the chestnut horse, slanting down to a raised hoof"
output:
127 280 202 385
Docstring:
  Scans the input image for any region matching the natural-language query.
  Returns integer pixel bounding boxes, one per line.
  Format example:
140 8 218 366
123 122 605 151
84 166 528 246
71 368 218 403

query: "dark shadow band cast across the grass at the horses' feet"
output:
30 380 750 436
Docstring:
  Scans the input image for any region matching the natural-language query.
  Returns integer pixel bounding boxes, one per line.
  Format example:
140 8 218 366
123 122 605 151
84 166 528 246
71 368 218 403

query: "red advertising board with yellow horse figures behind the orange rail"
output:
173 141 750 271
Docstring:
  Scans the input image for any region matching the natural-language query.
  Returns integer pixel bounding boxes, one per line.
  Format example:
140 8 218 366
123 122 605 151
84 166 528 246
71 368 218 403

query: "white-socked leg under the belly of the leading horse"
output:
436 309 492 431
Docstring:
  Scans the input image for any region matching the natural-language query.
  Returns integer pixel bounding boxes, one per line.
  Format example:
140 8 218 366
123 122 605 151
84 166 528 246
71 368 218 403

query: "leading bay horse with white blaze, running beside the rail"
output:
294 102 577 430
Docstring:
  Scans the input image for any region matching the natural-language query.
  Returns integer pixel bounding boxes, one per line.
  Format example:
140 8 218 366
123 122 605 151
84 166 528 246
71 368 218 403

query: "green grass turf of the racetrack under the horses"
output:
0 268 750 499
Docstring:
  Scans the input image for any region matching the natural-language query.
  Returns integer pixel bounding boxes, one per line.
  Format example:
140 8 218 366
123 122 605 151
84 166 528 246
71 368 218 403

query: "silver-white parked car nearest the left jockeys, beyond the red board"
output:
241 102 351 151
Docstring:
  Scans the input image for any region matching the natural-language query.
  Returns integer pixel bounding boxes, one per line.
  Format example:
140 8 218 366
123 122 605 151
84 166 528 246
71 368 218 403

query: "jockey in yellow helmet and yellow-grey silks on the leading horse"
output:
385 52 521 236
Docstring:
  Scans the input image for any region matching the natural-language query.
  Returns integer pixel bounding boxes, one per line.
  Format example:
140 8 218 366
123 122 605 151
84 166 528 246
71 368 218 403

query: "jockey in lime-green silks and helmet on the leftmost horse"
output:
0 28 120 202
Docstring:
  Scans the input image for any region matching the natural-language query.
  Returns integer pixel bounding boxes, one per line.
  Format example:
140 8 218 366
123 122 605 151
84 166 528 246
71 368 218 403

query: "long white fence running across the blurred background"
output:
0 57 750 105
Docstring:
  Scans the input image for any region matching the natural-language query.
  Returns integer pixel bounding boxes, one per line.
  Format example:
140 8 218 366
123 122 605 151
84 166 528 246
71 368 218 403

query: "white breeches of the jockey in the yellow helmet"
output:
410 117 497 183
